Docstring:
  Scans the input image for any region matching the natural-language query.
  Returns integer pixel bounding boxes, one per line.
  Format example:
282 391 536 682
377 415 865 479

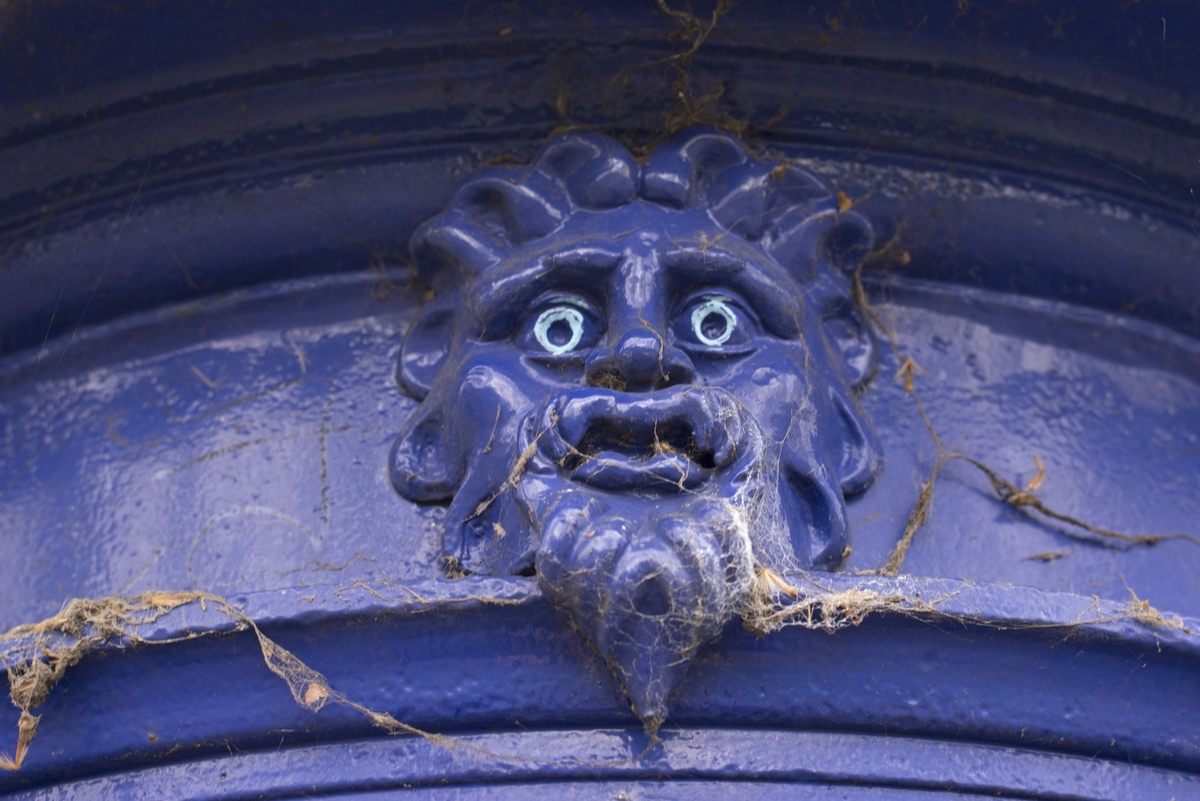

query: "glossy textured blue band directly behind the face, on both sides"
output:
0 266 1200 627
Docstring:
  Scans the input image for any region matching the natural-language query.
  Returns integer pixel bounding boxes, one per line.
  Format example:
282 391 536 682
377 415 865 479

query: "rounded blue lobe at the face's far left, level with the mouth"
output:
388 404 462 504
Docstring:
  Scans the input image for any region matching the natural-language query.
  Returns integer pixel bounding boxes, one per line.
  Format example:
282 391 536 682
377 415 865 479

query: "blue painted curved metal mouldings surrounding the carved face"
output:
0 0 1200 799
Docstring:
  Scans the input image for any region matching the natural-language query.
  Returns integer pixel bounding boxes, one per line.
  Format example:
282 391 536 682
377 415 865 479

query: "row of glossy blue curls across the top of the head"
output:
410 128 874 295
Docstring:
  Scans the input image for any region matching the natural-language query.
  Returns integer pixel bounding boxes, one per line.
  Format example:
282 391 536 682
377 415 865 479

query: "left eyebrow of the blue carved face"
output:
474 248 623 338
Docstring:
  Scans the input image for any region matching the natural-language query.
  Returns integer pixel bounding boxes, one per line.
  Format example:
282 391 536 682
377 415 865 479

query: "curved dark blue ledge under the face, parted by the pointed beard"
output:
0 576 1200 797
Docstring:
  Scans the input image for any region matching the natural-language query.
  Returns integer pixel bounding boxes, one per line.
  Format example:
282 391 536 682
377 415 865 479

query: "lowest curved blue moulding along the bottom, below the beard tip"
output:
11 729 1200 801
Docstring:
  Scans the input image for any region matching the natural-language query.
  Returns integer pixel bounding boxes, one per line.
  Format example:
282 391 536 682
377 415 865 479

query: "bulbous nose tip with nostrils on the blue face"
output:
584 327 696 392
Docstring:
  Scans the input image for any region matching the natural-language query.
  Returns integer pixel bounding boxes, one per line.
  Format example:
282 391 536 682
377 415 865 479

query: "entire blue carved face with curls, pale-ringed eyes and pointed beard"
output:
391 132 876 728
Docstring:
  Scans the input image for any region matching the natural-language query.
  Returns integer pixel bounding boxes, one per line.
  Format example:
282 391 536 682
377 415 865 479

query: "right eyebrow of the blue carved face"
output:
659 247 802 339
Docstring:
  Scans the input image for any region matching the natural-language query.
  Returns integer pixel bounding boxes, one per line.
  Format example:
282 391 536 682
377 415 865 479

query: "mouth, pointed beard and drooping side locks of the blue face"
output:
432 377 845 733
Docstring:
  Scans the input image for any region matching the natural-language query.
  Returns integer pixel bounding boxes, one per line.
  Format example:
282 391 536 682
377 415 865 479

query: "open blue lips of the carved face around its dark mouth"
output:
539 386 746 493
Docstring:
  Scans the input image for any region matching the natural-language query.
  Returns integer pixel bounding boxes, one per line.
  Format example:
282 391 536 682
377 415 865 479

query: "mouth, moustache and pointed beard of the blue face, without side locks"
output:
508 386 787 731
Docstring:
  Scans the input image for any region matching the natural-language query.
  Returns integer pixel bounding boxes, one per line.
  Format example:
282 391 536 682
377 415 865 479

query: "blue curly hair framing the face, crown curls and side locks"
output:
390 130 878 570
